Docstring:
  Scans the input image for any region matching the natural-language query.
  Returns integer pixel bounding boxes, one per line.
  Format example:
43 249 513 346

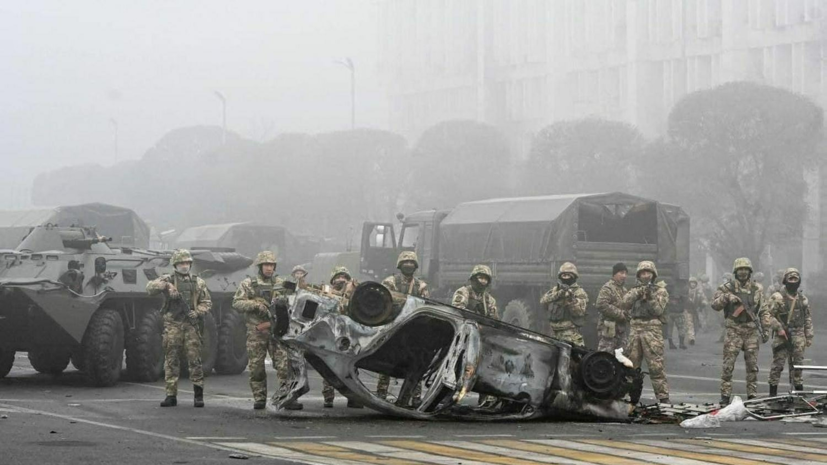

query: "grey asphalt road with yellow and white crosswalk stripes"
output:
0 326 827 464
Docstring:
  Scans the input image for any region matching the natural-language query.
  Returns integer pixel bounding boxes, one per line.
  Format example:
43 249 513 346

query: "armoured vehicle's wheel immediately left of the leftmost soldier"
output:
126 310 164 382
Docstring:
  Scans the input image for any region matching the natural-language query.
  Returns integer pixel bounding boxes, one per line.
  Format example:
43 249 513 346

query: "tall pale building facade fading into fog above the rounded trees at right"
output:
377 0 827 269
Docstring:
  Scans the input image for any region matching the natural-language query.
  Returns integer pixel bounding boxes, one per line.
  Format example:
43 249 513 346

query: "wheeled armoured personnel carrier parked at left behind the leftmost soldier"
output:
0 225 252 386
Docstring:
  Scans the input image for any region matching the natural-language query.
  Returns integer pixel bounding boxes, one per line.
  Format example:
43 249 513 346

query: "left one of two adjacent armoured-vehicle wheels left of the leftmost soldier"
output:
83 308 124 386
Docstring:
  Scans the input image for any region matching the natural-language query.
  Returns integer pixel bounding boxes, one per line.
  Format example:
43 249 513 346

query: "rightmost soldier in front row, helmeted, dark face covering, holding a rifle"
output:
767 268 815 396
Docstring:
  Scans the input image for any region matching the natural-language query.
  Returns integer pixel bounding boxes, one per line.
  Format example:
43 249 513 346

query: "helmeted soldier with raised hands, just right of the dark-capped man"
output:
622 261 671 404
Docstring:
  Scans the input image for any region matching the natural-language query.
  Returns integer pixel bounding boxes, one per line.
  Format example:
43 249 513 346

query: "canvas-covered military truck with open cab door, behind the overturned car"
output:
361 192 689 347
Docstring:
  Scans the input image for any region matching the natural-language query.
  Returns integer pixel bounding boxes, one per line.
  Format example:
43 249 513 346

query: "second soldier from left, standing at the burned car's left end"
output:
233 250 303 410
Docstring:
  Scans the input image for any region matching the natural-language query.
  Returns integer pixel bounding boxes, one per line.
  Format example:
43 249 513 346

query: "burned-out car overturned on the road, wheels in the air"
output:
273 282 642 421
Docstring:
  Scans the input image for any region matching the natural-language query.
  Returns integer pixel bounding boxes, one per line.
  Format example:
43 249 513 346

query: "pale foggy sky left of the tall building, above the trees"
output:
0 0 387 208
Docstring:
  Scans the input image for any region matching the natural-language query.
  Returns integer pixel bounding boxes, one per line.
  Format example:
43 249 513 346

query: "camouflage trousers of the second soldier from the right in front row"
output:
721 321 761 397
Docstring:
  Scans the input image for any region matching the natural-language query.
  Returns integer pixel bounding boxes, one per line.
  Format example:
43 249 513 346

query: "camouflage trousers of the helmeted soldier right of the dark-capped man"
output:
626 319 669 400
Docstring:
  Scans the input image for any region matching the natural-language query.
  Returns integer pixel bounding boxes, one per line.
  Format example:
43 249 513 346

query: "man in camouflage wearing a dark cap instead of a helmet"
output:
595 263 629 353
